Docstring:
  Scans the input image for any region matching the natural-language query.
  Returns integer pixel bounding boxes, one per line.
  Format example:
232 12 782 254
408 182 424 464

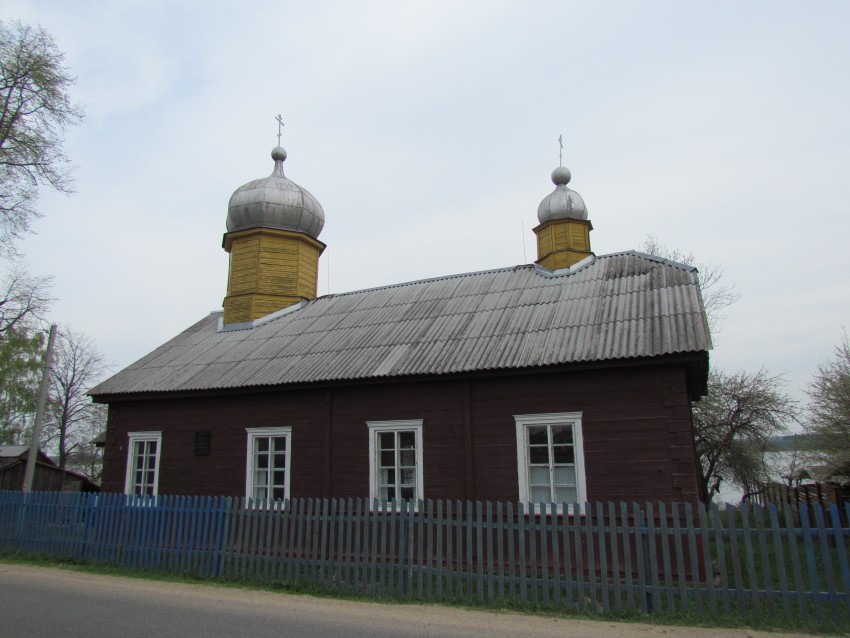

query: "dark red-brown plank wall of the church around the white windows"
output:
103 363 697 508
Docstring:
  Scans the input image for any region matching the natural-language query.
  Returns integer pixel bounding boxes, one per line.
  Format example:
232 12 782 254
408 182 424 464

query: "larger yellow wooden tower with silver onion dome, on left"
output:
222 146 325 325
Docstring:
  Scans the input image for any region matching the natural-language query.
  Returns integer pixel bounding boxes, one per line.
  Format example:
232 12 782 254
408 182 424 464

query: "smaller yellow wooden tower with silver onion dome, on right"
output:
534 166 593 270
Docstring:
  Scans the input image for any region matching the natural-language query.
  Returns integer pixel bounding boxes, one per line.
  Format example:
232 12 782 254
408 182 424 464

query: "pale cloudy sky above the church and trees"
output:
0 0 850 418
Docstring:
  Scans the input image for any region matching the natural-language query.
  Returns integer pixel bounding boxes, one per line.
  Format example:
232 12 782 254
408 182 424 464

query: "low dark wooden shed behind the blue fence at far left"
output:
0 445 100 492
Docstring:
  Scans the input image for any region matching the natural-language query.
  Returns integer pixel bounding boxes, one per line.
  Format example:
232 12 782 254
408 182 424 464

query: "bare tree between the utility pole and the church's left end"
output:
42 329 107 469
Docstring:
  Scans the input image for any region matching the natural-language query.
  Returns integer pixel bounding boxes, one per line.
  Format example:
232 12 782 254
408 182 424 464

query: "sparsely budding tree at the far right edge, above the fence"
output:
806 332 850 476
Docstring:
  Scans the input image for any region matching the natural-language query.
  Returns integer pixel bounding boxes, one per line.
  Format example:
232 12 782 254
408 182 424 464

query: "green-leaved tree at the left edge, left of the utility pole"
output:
0 325 44 444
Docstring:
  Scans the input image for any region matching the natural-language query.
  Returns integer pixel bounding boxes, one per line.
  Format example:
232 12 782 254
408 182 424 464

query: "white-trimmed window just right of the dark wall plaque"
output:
245 427 292 501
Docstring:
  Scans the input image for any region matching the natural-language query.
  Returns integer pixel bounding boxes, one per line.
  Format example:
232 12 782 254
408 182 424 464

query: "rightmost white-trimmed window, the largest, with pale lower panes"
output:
514 412 587 505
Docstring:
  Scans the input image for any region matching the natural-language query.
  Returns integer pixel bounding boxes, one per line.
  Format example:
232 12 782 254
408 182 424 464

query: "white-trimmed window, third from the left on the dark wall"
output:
366 419 423 501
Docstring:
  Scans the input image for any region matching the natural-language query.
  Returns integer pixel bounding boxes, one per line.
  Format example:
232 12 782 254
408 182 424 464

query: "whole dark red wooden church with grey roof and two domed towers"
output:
91 148 711 503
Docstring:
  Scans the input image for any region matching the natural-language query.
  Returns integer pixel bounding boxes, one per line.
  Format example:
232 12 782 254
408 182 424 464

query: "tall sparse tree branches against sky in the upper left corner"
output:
0 21 83 252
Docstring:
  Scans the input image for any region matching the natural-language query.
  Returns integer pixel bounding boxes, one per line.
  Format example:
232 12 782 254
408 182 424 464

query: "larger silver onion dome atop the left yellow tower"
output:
227 146 325 239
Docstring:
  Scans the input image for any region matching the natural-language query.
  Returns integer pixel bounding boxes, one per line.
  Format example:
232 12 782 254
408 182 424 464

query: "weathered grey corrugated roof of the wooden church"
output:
91 252 711 395
